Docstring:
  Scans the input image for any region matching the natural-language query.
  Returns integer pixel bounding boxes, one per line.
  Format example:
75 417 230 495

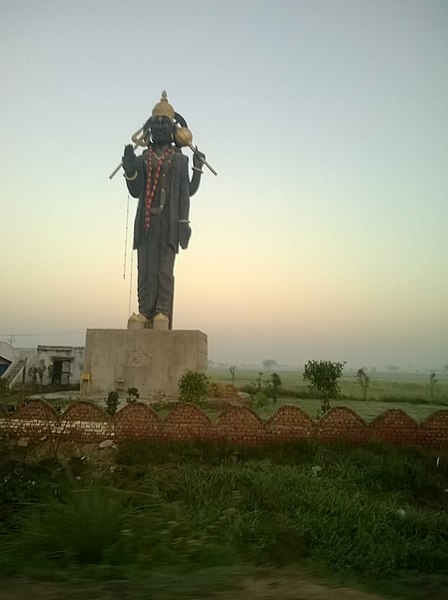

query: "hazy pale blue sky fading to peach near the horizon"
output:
0 0 448 369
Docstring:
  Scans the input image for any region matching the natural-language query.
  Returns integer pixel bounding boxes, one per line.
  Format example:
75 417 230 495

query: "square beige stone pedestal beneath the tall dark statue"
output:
81 329 207 399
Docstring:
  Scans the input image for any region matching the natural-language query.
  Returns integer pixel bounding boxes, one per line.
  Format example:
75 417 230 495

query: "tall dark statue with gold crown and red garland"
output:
122 92 205 328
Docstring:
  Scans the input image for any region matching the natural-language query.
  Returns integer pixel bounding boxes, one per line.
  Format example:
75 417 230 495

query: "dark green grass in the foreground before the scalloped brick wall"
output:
0 442 448 600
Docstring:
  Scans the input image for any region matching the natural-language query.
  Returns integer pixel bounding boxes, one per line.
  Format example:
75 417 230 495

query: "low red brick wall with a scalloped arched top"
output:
0 400 448 450
